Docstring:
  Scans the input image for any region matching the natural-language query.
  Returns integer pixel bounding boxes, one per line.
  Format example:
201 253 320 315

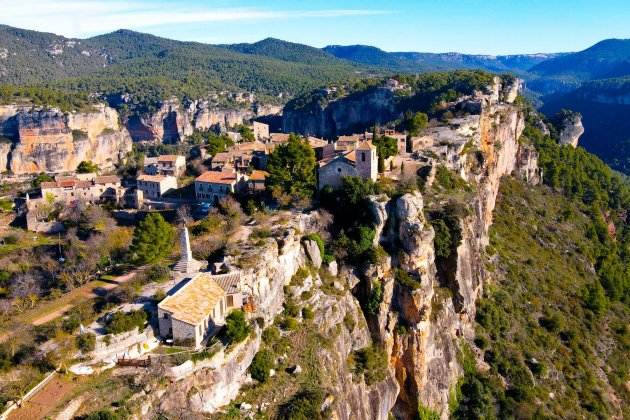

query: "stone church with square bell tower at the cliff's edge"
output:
317 141 378 189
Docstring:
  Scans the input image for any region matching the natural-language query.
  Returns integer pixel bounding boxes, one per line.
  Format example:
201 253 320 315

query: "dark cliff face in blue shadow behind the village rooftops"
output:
282 87 398 139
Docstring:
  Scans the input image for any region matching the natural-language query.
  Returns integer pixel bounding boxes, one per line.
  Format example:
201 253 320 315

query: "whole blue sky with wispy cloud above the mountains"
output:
0 0 630 55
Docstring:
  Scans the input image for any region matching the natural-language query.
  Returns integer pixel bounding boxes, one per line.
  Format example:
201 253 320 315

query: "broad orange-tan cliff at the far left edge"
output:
0 105 131 174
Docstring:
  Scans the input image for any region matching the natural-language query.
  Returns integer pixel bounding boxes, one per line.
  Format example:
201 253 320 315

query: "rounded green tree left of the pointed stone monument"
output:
131 213 175 264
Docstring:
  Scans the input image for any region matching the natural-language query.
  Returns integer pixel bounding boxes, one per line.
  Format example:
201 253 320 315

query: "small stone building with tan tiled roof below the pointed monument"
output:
158 272 243 348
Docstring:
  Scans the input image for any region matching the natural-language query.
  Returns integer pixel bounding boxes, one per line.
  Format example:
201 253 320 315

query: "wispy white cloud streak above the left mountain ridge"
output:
0 0 390 37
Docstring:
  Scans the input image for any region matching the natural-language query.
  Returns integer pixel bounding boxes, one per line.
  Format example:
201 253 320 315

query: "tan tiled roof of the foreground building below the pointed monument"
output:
158 273 225 325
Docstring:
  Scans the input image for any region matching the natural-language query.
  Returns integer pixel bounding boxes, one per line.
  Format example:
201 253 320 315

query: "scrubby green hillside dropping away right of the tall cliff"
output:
456 179 630 418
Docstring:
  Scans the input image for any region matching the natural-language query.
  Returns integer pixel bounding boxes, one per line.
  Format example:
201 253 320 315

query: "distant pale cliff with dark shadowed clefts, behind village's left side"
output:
125 98 255 143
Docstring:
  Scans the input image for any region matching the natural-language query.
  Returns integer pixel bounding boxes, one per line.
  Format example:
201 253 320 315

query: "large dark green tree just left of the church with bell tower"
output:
265 134 316 198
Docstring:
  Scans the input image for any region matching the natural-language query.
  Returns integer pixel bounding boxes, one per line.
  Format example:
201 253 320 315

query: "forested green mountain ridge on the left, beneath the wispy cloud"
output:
0 26 370 108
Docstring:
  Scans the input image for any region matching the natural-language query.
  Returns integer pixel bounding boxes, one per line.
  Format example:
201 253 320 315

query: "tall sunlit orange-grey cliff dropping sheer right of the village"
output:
372 81 538 419
